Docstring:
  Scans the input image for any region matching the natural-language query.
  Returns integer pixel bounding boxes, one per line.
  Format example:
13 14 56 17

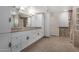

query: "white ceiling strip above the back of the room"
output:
34 6 72 13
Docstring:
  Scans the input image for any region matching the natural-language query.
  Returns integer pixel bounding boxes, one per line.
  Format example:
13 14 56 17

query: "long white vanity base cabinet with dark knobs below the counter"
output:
11 29 43 52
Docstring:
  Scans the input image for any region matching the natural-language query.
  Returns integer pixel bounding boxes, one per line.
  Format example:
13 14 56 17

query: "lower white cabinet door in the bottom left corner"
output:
0 34 10 52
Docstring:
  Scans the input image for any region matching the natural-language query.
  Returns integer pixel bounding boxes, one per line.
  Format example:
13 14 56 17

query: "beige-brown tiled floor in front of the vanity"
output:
23 36 78 52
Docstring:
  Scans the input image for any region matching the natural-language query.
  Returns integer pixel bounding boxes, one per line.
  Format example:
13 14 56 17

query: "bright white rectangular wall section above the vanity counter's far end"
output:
31 14 44 27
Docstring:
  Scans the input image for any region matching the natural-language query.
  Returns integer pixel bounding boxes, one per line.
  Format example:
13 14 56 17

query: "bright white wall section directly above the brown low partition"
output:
59 11 69 27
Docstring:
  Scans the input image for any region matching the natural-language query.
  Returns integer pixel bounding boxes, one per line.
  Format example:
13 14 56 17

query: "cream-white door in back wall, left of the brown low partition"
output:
50 15 59 36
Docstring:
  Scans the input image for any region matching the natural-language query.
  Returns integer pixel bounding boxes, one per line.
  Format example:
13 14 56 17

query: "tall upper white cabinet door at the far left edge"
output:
0 6 11 33
